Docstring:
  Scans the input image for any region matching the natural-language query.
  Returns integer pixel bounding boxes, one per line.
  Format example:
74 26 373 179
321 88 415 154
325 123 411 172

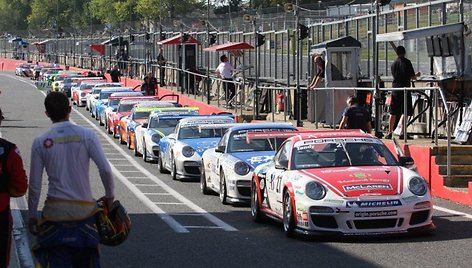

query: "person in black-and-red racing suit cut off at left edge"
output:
0 110 28 267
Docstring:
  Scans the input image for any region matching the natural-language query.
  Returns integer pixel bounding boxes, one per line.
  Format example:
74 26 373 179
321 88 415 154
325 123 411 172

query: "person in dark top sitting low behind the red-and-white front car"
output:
339 96 372 133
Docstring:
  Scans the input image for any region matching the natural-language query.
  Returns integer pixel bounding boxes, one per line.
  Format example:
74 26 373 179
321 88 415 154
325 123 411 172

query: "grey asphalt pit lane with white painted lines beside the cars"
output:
0 72 472 267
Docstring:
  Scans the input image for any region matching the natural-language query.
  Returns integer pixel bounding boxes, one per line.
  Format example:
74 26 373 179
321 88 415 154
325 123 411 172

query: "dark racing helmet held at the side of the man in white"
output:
97 200 131 246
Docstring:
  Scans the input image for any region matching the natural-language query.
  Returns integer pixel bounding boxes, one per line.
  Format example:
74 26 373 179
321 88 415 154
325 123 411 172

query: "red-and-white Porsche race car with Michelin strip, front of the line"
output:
251 130 435 236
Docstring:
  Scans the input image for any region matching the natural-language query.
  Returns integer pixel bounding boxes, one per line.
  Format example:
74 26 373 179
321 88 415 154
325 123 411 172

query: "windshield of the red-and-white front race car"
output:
292 139 398 169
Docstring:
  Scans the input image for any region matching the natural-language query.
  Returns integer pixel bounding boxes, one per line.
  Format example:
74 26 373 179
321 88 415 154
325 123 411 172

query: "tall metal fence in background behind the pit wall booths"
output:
0 0 471 137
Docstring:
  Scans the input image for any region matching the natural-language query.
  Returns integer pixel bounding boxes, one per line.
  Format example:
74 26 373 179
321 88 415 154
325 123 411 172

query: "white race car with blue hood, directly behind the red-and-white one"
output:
200 123 297 204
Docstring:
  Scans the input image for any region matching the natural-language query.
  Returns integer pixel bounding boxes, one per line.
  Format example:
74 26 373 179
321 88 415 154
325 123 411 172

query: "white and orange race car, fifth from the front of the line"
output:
118 101 174 150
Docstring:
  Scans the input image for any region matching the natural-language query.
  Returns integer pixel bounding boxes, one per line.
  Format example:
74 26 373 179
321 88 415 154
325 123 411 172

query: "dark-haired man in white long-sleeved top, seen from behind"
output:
28 92 114 267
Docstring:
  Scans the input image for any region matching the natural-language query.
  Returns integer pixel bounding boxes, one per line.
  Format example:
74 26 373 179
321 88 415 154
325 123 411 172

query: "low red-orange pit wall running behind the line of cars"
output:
0 59 472 206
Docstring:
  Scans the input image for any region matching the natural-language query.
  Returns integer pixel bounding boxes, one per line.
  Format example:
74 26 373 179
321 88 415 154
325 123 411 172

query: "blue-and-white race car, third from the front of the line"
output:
158 115 235 180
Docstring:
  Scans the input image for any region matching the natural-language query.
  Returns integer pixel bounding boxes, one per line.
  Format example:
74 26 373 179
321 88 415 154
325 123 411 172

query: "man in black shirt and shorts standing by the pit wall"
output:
385 46 421 139
